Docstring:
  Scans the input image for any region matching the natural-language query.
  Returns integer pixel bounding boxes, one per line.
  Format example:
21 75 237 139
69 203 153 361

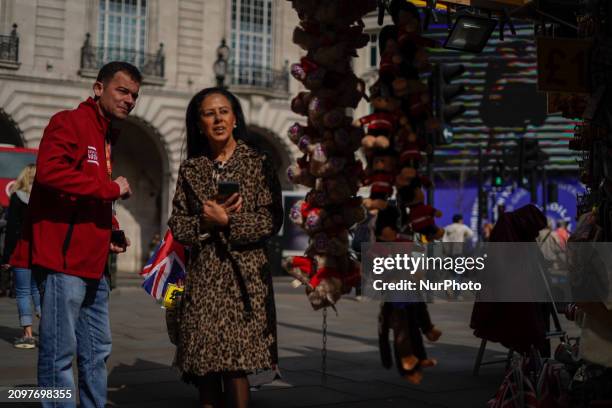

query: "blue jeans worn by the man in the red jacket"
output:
38 270 111 408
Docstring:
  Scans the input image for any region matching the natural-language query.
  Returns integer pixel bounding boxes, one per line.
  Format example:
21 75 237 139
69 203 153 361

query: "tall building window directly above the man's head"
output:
98 0 147 66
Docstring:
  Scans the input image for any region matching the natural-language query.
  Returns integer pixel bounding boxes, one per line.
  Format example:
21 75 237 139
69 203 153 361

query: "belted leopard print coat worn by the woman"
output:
168 141 283 381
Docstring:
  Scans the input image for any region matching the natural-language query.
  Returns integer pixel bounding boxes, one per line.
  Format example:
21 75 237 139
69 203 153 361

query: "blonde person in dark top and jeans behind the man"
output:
2 164 40 349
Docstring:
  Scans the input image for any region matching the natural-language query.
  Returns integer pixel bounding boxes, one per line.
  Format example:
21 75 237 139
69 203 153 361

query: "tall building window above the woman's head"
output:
231 0 272 85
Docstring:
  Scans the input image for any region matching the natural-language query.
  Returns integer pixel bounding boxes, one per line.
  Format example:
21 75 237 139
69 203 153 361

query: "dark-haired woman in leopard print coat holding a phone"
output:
168 88 283 406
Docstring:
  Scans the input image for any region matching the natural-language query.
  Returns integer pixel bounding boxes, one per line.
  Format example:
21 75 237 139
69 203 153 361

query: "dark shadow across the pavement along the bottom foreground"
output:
108 345 504 408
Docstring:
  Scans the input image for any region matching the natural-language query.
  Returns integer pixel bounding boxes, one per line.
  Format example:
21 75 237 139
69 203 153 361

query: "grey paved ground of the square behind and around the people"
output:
0 278 580 408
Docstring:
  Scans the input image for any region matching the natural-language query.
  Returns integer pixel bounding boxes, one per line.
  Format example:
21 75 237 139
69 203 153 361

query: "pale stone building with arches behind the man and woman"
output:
0 0 376 271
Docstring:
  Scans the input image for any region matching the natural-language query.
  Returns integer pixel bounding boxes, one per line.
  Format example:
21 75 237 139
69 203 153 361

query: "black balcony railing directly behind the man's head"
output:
81 33 165 83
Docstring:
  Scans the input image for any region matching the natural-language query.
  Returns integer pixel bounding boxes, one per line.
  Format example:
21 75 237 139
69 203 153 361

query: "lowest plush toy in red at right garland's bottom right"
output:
398 177 444 241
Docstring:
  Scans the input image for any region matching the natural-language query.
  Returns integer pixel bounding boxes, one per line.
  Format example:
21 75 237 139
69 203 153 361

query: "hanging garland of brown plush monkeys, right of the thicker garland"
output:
355 0 443 240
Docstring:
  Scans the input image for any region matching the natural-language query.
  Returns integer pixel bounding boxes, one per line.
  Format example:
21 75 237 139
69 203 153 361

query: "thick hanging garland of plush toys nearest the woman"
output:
284 0 377 310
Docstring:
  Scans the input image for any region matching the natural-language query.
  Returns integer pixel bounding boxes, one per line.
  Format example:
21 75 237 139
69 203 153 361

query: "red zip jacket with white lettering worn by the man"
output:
11 98 119 279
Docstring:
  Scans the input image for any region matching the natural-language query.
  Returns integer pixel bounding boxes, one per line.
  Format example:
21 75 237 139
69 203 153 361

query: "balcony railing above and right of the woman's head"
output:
230 64 289 93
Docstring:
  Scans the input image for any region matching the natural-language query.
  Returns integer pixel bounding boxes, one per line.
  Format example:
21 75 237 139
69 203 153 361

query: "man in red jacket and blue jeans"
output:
11 62 142 407
